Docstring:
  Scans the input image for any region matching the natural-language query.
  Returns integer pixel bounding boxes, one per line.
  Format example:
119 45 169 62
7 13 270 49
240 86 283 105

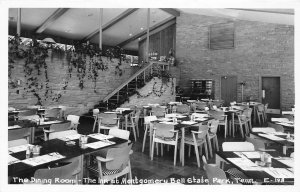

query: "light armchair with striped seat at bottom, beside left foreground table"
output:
87 144 132 184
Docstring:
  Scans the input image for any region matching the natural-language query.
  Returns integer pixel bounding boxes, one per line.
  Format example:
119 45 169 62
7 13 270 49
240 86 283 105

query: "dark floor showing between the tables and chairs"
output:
78 117 272 184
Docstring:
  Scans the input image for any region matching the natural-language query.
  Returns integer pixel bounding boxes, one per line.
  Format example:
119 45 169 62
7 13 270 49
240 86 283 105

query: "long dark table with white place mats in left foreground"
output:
8 133 128 183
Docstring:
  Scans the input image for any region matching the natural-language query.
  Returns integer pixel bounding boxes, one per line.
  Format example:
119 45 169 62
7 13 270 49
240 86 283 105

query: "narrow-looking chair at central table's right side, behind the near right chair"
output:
208 119 219 157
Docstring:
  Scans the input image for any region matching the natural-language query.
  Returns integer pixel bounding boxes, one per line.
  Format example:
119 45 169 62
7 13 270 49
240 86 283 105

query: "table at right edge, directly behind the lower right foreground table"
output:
250 132 294 155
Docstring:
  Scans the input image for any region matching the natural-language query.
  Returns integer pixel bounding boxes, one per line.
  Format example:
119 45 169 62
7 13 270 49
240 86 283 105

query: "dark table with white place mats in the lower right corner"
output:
216 151 294 185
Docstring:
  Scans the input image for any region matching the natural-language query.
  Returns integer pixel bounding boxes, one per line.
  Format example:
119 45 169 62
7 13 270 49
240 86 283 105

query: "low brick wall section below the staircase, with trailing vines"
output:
121 77 176 108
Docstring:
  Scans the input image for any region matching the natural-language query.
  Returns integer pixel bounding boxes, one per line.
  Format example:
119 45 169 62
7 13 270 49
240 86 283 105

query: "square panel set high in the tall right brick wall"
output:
209 23 234 50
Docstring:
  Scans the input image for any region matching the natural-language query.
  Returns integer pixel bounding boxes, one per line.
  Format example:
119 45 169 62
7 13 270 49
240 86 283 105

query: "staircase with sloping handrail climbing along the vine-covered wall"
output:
94 61 169 111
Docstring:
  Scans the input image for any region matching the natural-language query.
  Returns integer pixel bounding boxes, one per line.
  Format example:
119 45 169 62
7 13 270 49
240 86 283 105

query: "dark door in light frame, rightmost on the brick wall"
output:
261 77 280 109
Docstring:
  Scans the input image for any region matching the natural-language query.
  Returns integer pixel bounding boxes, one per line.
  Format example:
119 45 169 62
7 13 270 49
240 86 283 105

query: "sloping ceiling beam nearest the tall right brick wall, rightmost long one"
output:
117 16 176 47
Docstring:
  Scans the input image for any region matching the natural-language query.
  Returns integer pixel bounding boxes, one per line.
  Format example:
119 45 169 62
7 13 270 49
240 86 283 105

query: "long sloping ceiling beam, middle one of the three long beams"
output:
83 8 138 41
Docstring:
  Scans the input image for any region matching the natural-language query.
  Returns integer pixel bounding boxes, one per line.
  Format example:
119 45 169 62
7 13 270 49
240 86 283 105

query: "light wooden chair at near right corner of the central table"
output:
184 124 208 167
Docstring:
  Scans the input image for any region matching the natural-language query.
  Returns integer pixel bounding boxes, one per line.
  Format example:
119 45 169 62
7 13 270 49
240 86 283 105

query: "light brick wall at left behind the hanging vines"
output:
8 50 134 115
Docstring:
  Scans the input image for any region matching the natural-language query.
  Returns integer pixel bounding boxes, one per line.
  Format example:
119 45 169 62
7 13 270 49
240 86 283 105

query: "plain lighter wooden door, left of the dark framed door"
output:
221 76 237 106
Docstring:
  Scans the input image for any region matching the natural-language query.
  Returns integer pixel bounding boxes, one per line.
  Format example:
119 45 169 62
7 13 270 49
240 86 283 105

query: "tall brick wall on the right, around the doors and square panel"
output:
175 13 295 109
